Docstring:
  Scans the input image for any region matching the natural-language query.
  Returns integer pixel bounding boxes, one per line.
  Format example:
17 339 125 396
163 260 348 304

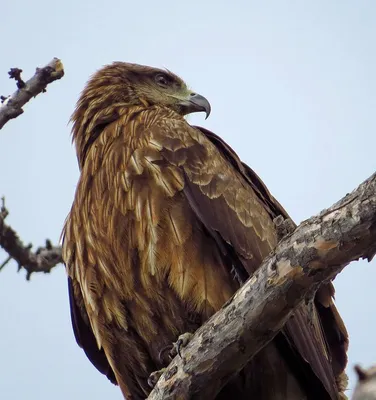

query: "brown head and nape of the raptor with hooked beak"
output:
72 62 210 166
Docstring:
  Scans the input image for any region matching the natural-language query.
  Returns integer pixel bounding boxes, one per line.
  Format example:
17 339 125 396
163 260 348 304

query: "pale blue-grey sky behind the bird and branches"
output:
0 0 376 400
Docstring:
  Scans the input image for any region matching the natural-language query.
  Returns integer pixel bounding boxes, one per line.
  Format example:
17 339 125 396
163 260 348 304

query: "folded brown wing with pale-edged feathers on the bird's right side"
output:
154 124 347 399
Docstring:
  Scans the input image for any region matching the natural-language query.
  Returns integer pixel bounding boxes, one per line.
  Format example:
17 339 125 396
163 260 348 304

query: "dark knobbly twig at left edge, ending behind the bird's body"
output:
0 198 62 280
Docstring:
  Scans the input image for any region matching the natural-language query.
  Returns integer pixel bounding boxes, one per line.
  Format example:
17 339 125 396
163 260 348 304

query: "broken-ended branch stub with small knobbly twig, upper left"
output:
0 58 64 129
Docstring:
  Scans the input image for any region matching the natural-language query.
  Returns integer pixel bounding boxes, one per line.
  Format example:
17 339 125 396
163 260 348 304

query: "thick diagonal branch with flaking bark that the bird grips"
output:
148 174 376 400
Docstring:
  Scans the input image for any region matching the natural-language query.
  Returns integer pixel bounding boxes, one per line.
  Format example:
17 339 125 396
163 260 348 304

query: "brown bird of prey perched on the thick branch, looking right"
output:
63 62 348 400
